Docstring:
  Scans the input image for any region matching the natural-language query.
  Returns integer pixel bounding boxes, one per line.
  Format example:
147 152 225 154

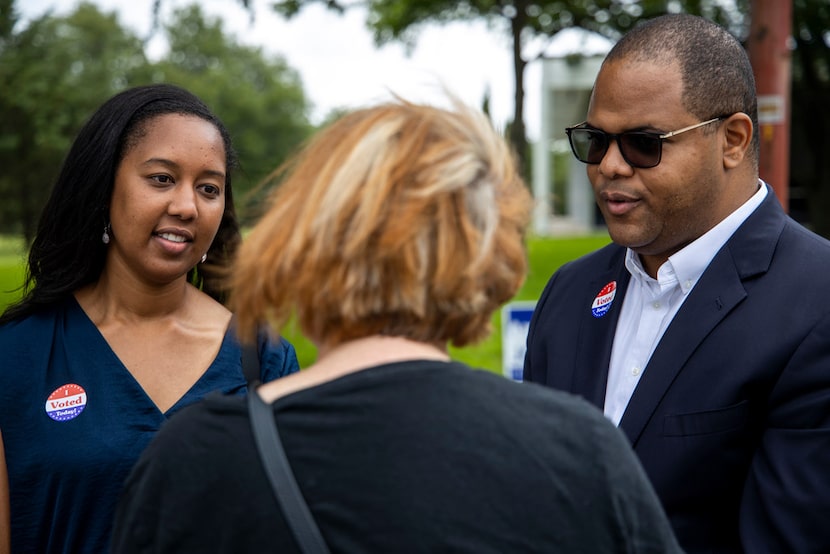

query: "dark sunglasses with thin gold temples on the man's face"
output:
565 116 728 169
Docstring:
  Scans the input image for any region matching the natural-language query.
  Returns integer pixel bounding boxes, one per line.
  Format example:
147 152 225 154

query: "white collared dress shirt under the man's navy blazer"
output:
604 181 767 425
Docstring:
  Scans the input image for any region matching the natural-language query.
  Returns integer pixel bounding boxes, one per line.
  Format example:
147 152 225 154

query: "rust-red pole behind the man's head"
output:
747 0 793 211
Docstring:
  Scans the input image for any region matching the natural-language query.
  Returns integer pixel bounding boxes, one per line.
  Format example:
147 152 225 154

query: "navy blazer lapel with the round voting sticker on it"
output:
572 247 631 409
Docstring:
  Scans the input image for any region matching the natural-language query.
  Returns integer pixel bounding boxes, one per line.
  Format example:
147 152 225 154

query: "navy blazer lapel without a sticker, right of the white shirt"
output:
620 187 786 444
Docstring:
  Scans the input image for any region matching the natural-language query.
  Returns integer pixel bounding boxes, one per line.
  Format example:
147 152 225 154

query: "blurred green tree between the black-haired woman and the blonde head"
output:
148 5 313 217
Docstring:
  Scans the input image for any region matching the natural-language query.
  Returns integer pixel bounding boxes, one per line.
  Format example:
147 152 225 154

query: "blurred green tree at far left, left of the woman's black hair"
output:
0 0 148 240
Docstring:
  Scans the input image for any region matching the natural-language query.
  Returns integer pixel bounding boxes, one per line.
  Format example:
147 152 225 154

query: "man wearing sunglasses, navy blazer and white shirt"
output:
524 15 830 553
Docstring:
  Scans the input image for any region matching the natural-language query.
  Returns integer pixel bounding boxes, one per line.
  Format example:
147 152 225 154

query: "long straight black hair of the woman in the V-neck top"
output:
0 84 241 323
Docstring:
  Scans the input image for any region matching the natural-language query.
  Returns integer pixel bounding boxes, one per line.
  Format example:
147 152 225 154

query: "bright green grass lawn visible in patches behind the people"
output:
0 234 610 373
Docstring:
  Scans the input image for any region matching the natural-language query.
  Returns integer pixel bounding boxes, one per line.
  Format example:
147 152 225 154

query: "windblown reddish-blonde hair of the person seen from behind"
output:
231 95 531 346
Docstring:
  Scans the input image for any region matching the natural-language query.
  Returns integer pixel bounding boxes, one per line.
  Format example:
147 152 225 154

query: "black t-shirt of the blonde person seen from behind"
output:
113 361 679 554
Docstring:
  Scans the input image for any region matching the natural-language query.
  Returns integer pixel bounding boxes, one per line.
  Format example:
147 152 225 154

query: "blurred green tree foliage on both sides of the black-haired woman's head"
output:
0 0 311 240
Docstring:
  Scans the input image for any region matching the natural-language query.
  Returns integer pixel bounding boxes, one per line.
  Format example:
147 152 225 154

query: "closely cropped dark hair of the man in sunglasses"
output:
603 14 760 169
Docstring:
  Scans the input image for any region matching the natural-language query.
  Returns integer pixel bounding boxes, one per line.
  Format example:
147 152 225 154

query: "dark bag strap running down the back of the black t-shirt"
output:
248 388 329 554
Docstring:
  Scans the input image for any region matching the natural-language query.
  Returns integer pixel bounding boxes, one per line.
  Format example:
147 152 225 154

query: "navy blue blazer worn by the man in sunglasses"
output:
524 189 830 552
